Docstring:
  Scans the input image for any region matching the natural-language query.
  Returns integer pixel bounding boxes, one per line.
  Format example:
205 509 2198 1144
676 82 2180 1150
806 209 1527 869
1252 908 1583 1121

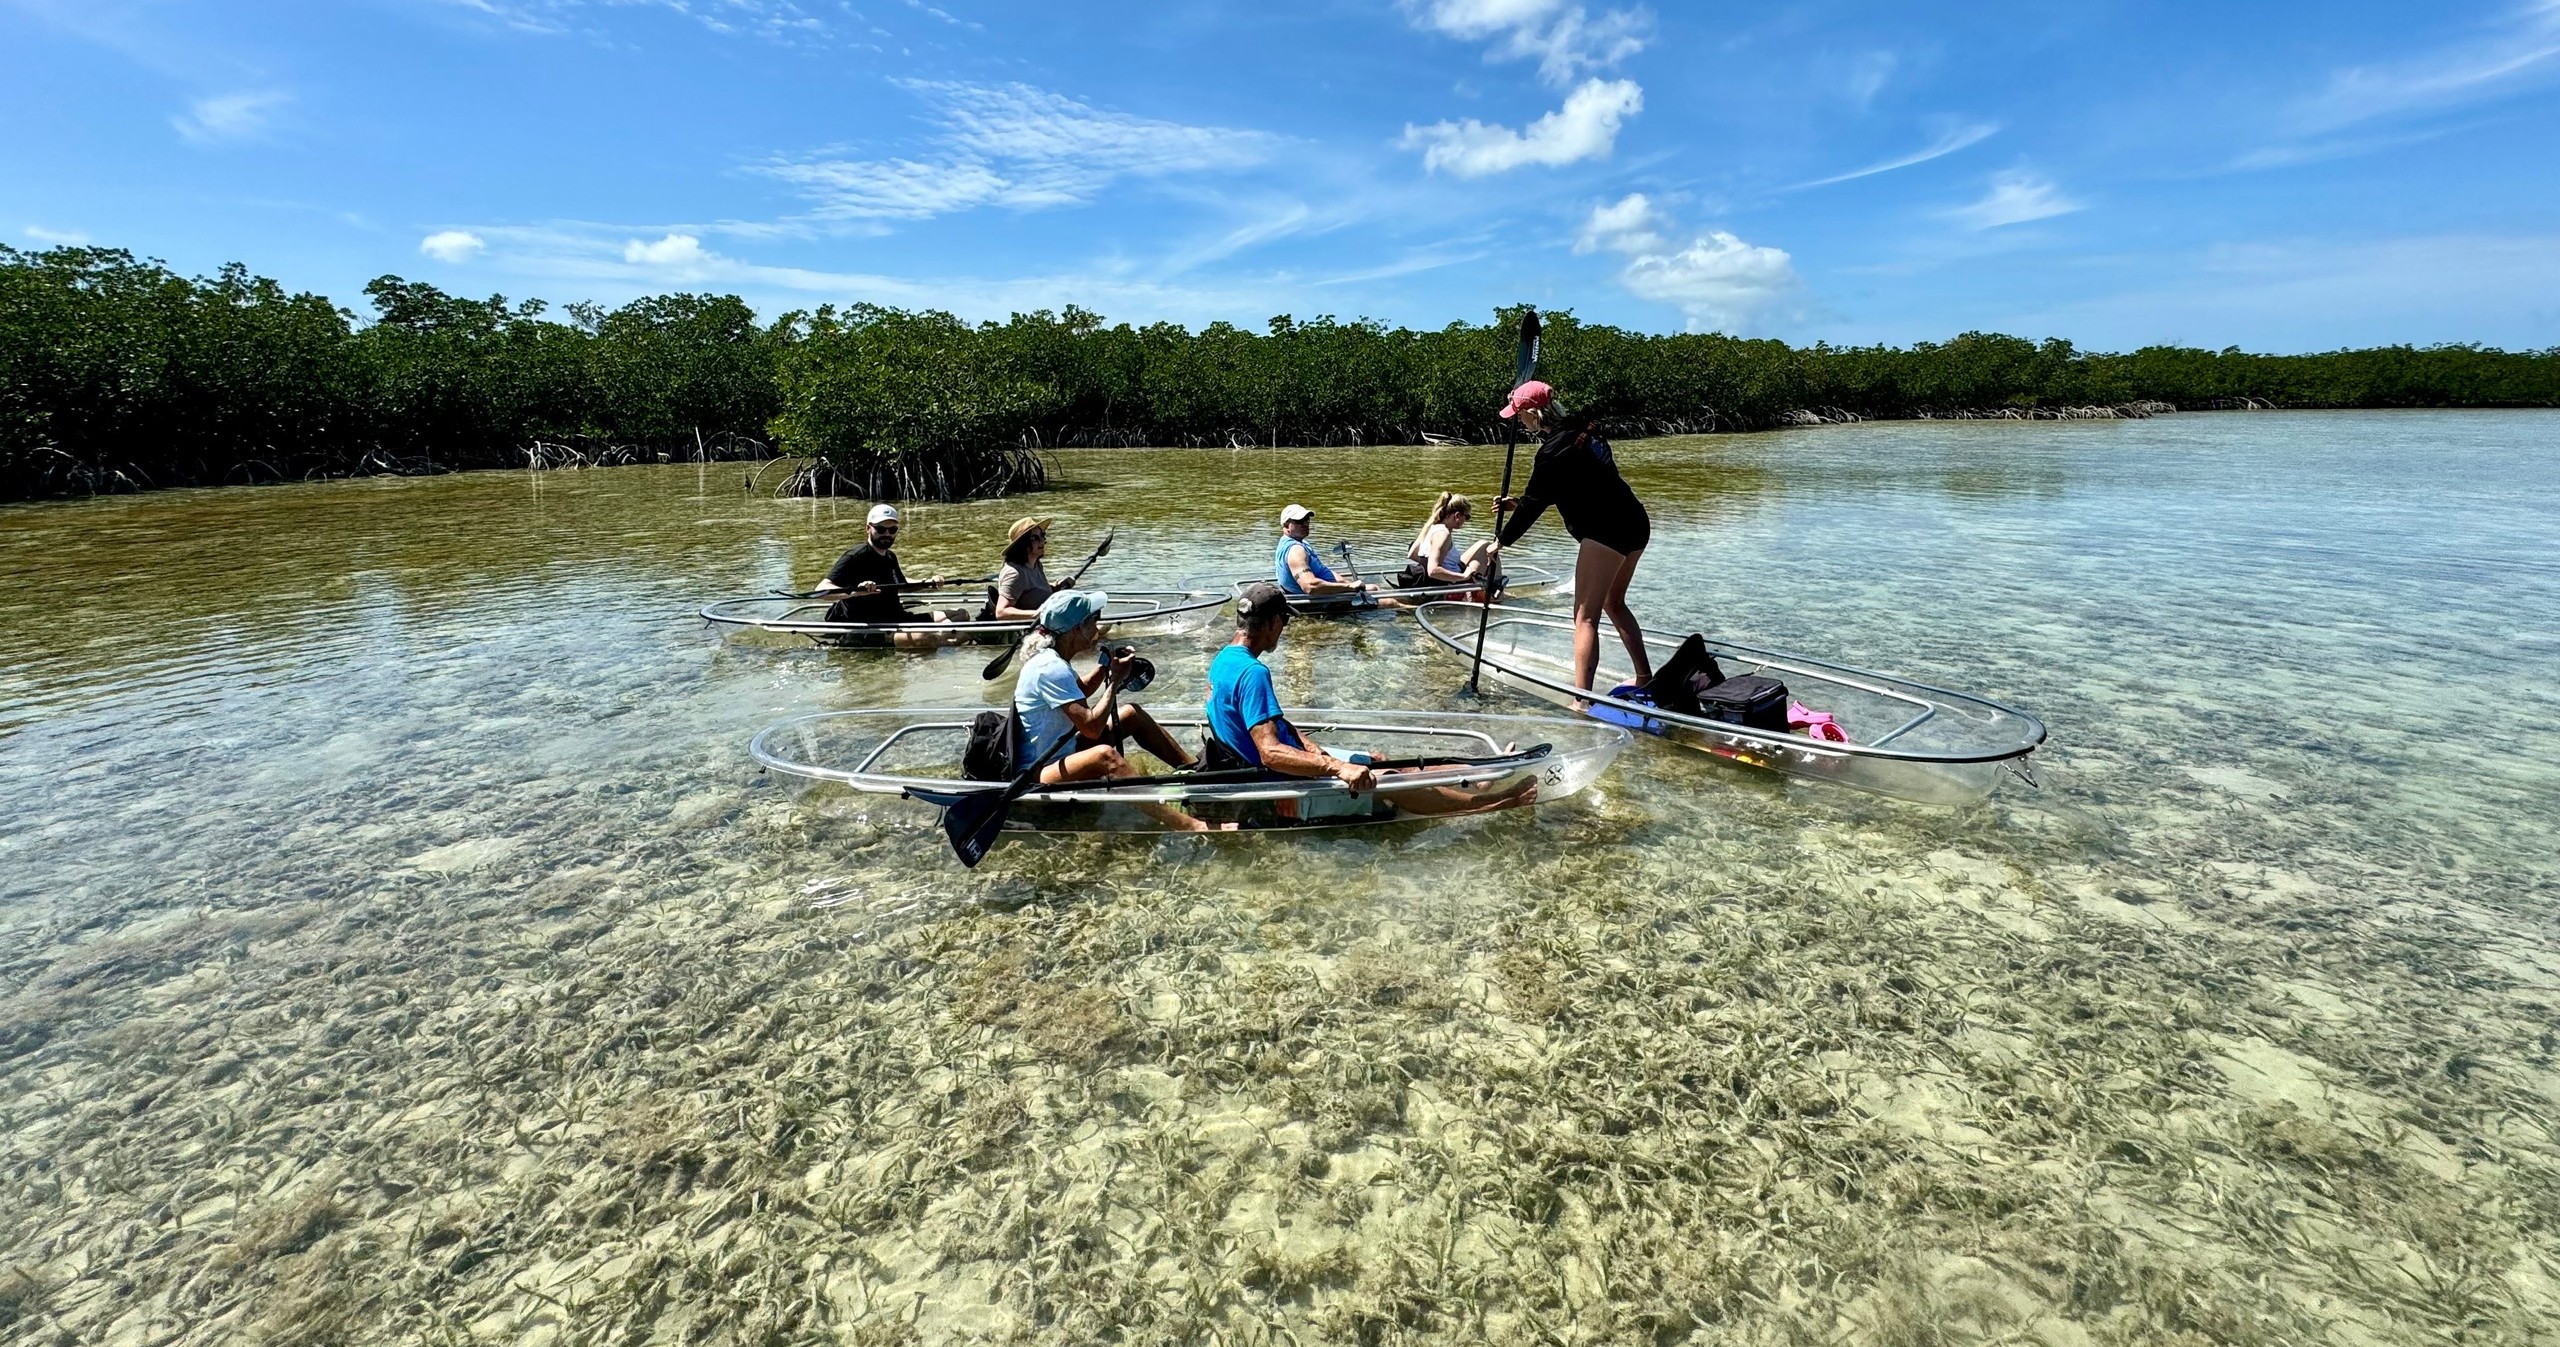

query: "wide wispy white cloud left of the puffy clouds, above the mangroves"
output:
765 82 1272 220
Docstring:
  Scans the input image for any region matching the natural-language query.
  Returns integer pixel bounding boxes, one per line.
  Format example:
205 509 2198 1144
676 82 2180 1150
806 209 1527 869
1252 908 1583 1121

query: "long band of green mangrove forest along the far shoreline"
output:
0 246 2560 499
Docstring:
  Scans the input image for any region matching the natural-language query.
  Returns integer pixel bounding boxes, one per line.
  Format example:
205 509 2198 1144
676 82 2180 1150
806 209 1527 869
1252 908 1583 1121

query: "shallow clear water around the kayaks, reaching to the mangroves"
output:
0 412 2560 1342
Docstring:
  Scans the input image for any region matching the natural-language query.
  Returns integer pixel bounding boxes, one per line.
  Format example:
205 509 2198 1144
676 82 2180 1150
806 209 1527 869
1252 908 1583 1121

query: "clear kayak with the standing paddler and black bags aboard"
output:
1416 604 2045 804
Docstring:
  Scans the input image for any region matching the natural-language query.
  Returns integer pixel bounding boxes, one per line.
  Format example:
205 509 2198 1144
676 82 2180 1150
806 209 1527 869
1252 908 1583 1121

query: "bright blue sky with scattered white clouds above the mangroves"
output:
0 0 2560 351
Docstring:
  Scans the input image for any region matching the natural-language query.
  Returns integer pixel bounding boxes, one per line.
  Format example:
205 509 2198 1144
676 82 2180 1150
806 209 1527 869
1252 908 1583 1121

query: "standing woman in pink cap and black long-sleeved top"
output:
1492 379 1654 691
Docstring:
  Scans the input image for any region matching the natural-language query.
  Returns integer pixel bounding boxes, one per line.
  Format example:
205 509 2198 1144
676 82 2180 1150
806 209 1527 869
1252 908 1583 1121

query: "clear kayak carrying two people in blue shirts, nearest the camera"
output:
748 707 1631 832
